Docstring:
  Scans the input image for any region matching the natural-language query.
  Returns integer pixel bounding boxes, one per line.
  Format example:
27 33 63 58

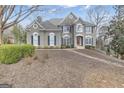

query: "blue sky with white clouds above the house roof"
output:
21 5 115 27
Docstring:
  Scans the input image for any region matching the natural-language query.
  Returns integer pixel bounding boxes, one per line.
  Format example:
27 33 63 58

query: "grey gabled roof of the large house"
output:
27 12 95 30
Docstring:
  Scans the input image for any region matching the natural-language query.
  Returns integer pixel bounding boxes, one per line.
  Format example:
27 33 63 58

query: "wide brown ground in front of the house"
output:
0 49 124 88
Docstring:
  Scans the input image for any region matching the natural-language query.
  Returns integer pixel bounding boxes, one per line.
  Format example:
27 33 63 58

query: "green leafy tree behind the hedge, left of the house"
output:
12 25 26 44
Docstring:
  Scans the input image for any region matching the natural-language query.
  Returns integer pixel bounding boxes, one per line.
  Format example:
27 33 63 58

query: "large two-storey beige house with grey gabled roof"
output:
26 13 96 48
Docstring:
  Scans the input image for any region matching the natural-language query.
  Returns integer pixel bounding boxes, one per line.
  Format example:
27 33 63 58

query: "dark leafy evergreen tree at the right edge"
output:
109 6 124 57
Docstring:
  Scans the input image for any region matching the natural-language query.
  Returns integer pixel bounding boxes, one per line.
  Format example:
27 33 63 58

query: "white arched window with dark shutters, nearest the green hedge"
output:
31 32 40 46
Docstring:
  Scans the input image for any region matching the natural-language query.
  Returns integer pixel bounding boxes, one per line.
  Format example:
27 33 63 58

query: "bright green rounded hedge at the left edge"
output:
0 44 35 64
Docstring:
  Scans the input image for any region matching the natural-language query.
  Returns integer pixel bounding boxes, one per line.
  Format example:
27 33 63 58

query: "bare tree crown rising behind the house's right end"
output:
87 6 110 36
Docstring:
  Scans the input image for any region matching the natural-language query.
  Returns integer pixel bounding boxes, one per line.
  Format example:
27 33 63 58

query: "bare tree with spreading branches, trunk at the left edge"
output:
0 5 39 45
